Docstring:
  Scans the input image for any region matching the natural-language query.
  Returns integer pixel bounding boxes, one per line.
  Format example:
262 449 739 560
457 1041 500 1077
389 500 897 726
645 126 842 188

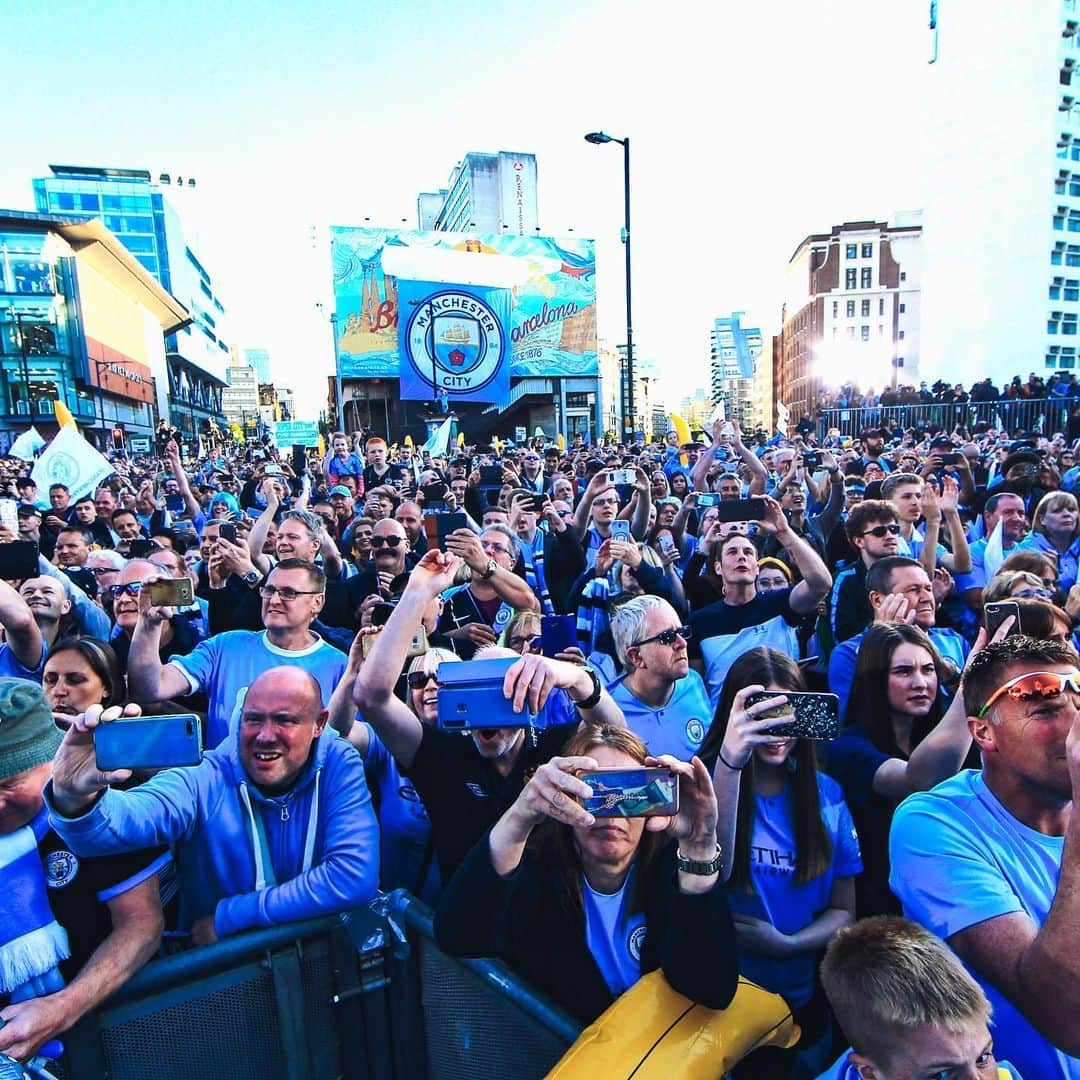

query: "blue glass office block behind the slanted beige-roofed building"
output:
33 165 229 441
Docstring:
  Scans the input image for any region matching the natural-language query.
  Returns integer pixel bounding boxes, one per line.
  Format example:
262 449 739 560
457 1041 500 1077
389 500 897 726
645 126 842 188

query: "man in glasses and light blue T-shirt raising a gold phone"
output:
127 558 346 748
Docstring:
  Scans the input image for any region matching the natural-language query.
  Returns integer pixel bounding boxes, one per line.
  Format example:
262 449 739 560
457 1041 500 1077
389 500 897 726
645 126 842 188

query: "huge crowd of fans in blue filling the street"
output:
0 410 1080 1080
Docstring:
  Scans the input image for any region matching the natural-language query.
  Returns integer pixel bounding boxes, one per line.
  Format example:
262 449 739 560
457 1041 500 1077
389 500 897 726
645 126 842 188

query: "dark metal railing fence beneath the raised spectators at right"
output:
818 397 1080 438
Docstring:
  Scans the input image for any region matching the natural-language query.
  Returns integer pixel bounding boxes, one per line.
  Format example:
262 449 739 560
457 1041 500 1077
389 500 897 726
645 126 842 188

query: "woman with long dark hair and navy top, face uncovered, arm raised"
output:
825 617 993 918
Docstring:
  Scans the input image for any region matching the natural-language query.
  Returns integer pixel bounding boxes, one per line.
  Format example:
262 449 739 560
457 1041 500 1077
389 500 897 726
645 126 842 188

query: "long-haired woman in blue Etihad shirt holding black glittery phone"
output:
701 648 863 1078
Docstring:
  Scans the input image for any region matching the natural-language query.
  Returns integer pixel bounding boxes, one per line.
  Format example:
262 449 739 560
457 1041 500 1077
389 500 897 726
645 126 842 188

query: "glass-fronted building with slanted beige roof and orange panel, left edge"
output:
0 211 188 451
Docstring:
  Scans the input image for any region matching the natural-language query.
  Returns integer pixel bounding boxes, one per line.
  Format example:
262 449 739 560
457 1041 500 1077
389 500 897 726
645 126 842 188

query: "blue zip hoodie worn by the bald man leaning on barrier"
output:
45 727 379 937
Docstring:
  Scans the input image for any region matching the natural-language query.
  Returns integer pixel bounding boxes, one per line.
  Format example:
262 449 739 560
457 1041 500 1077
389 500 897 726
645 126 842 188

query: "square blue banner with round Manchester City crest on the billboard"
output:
397 279 511 406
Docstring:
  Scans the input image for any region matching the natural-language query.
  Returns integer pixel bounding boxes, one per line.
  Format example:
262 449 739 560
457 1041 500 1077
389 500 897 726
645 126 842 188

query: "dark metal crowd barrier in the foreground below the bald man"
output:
53 893 580 1080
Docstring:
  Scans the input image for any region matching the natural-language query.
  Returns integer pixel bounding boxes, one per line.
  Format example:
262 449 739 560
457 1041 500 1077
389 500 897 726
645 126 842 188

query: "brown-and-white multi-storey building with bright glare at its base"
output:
772 214 924 421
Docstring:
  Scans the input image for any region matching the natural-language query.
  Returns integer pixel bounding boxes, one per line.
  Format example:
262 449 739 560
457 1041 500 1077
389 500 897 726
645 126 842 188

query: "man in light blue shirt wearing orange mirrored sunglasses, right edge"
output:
889 635 1080 1080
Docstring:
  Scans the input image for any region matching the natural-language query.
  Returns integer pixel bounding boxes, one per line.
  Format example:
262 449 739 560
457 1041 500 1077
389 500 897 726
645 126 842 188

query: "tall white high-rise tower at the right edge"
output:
921 0 1080 386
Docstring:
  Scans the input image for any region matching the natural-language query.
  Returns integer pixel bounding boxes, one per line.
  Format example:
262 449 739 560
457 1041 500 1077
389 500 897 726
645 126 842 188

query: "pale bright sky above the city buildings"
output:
0 0 930 418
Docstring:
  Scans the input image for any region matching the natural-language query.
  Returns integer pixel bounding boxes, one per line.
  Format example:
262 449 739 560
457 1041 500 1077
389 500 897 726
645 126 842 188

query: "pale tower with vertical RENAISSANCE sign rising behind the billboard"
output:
417 150 539 237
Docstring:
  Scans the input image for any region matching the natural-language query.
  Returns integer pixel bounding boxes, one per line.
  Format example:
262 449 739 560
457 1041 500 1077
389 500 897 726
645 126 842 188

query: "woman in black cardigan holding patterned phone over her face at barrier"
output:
435 726 738 1024
